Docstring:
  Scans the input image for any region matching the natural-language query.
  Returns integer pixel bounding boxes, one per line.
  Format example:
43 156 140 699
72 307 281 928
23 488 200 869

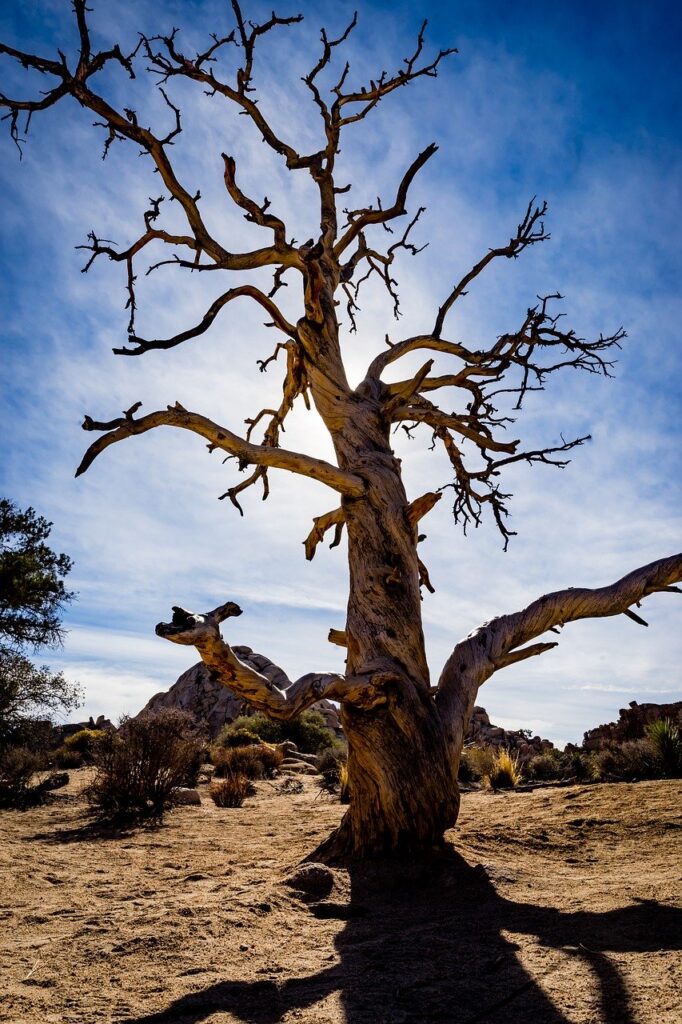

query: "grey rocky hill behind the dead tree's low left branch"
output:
140 647 341 739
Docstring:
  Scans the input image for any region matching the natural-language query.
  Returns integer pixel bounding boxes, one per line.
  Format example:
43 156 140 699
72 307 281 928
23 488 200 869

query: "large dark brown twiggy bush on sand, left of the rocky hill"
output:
86 708 204 818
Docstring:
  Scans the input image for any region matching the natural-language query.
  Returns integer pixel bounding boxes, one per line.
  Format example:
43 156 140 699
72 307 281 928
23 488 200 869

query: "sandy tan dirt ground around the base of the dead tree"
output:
0 770 682 1024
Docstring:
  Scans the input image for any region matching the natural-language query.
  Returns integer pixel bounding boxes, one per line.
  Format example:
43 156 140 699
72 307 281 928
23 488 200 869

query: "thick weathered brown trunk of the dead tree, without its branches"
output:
315 393 459 859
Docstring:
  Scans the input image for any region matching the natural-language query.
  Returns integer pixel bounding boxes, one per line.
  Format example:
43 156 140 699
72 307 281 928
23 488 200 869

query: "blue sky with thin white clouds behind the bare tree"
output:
0 0 682 741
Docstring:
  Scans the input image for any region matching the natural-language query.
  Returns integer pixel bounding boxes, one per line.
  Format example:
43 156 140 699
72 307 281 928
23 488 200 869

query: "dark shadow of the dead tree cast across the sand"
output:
119 852 682 1024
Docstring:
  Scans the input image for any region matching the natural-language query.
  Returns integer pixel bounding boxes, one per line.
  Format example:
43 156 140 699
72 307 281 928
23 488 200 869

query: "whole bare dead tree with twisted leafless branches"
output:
0 0 682 857
